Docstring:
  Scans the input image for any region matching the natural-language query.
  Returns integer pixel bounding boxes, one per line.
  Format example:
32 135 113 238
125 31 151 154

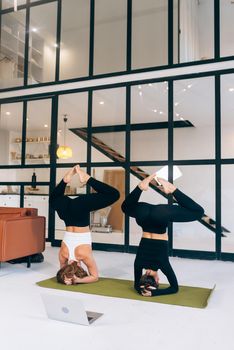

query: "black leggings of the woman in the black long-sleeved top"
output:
122 186 204 233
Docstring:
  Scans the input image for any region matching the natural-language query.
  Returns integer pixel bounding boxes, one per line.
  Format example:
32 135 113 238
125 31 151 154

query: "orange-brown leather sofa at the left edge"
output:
0 207 45 267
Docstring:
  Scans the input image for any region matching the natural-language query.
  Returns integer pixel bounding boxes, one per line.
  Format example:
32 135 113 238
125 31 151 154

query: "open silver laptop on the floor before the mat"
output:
41 294 103 326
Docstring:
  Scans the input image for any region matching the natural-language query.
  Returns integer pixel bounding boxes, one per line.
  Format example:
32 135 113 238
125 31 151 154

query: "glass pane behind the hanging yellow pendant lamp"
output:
57 92 88 163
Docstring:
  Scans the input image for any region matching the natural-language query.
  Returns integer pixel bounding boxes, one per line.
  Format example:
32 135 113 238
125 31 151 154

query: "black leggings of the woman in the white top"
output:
49 177 120 227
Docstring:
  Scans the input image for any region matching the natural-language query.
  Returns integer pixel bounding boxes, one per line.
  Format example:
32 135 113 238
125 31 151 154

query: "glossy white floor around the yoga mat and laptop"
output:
0 247 234 350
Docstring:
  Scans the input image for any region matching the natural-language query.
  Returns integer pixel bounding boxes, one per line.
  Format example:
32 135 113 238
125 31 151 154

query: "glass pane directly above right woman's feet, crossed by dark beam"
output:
131 82 168 161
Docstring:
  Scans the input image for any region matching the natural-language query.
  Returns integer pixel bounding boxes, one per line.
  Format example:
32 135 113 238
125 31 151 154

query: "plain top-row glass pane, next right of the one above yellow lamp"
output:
94 0 127 74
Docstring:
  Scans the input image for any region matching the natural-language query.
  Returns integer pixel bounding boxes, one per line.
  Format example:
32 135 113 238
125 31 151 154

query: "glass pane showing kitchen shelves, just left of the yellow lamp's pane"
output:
25 99 51 164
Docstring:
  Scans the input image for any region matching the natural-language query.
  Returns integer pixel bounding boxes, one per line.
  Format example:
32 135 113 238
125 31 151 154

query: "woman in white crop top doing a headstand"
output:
49 165 119 284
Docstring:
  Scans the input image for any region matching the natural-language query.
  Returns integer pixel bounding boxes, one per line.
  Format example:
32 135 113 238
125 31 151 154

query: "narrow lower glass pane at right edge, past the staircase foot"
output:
221 164 234 253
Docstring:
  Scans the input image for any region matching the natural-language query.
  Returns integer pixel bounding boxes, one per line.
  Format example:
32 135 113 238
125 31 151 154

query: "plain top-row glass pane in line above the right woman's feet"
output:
132 0 168 69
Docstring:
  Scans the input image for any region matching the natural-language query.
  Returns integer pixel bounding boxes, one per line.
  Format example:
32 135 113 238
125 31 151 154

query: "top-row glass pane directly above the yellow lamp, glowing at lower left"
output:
60 0 90 79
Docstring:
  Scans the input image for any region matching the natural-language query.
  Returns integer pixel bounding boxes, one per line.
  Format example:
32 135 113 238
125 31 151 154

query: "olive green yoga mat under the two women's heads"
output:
37 277 215 308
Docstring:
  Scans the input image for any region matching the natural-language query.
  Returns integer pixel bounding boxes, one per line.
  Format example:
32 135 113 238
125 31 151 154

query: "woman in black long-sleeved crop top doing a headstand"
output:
122 174 204 296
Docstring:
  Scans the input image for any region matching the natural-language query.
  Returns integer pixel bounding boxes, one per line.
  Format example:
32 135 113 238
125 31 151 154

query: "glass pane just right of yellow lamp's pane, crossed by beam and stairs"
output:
92 88 126 162
